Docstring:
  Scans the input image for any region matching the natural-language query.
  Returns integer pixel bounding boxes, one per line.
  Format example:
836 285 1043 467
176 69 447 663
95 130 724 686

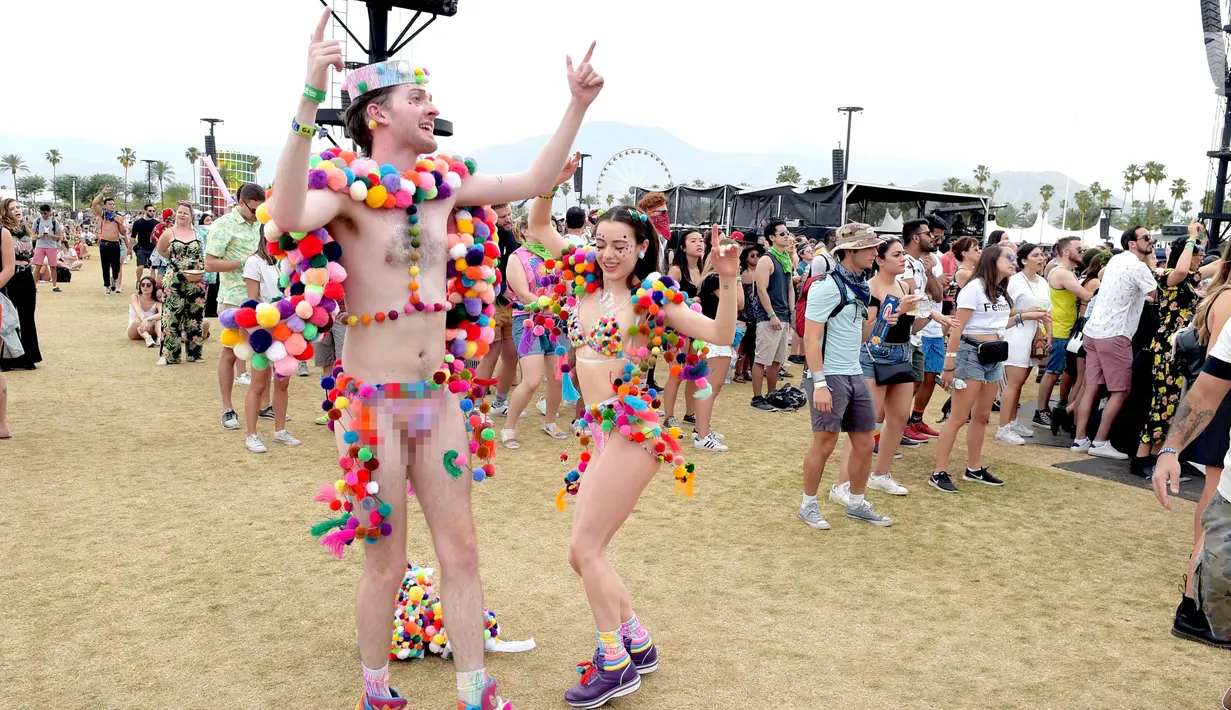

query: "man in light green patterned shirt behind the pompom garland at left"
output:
206 182 265 429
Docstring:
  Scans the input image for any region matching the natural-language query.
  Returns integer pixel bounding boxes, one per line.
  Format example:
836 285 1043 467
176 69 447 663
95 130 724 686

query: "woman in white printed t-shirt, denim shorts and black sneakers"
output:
928 245 1044 493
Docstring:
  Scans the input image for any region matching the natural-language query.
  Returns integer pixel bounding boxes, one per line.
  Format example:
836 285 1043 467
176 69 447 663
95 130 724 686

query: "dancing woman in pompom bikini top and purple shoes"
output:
565 205 740 708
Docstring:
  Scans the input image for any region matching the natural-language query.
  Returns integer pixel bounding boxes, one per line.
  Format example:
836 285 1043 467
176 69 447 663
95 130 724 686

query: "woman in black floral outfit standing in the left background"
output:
155 202 206 365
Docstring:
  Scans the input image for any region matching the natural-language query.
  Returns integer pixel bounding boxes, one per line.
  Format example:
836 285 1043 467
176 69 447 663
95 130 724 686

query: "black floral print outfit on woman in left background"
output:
162 239 206 364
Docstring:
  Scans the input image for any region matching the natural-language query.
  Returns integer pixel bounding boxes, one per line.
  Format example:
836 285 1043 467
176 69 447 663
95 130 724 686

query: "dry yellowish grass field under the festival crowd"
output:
0 257 1229 710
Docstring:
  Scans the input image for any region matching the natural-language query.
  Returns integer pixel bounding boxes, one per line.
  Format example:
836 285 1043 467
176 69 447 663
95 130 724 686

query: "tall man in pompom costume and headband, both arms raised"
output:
265 11 603 710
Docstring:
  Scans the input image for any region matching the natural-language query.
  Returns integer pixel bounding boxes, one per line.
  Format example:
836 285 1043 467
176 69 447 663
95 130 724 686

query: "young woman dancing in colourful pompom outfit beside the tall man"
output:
564 205 740 708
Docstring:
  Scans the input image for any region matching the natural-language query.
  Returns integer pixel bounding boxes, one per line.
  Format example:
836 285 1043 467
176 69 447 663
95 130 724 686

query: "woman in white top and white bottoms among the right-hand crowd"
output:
996 242 1051 445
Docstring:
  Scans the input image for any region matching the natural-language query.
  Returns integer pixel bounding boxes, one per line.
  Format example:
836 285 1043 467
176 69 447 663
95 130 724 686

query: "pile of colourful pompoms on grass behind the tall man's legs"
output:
389 565 500 661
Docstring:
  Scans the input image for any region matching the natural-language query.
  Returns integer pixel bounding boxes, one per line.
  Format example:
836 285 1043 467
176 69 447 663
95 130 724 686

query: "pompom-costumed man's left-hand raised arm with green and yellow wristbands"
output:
267 9 342 231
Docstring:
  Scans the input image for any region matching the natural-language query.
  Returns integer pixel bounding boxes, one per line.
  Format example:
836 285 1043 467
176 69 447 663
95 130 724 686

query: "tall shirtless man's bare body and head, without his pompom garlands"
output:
268 10 603 710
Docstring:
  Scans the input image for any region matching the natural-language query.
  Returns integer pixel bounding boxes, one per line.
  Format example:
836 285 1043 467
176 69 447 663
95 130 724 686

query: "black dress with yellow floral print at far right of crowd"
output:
1141 268 1198 445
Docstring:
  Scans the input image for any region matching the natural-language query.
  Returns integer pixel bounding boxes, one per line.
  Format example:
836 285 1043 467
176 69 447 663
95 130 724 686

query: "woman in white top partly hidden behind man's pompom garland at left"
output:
244 233 299 454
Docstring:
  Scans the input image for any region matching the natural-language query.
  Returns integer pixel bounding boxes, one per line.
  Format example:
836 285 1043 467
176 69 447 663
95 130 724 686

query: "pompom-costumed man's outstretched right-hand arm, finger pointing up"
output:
458 42 603 204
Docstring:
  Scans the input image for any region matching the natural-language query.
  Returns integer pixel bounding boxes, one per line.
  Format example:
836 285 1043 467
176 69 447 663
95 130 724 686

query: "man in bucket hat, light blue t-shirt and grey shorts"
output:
799 223 892 530
